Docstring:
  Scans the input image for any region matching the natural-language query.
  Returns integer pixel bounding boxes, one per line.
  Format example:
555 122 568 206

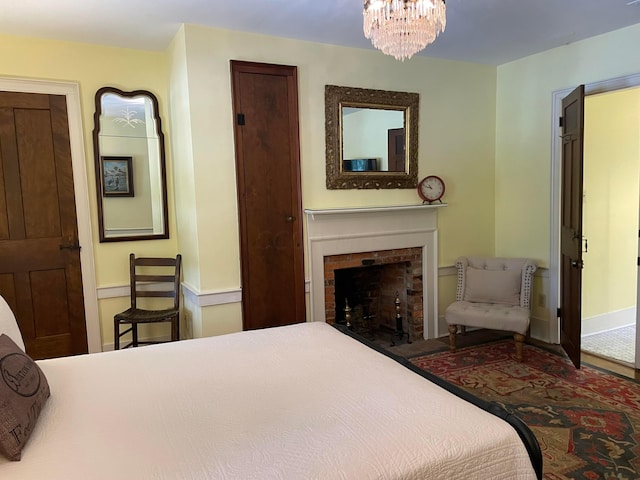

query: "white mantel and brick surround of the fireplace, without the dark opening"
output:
305 204 446 339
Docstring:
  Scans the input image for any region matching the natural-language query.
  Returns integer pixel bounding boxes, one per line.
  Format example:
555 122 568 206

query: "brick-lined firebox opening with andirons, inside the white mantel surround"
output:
324 247 424 341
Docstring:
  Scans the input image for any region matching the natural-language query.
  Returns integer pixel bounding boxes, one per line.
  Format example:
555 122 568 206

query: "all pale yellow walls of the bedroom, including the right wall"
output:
7 20 640 343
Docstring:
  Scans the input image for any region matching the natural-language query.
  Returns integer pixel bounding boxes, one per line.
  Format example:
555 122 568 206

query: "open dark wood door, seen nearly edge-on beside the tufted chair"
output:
560 85 584 368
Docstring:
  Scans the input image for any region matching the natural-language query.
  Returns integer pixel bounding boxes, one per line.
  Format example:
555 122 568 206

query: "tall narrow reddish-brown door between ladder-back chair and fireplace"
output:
231 61 305 330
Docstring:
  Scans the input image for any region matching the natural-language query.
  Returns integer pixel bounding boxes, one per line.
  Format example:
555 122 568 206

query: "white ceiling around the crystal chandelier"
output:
0 0 640 65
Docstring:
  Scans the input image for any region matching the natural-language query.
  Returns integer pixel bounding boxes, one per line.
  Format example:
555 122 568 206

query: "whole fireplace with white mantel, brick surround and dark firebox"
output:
305 204 446 339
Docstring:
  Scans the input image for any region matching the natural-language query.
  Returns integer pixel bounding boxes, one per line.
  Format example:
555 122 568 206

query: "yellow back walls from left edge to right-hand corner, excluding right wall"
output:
0 25 496 344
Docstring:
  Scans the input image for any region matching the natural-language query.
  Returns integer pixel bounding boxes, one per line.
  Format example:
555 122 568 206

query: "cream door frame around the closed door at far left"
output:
0 77 102 353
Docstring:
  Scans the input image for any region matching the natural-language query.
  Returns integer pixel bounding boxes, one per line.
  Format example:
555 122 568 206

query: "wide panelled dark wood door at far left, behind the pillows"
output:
0 92 88 359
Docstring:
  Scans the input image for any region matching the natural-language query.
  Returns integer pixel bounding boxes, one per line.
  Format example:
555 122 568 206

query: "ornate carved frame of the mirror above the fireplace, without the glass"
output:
324 85 420 190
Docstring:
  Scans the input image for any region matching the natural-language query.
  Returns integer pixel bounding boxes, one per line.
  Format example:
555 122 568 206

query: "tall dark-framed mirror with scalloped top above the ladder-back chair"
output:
93 87 169 242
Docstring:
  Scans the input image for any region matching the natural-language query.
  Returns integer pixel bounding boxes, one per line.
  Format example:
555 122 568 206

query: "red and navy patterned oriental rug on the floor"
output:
410 340 640 480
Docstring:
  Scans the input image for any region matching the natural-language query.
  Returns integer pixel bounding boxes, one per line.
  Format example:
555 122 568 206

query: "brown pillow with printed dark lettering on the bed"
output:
0 334 50 460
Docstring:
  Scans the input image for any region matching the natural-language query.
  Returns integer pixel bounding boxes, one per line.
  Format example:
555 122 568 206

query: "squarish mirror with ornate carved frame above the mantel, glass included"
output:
325 85 420 190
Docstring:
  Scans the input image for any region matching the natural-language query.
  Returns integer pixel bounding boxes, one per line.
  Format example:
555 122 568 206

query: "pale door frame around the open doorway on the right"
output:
547 73 640 344
